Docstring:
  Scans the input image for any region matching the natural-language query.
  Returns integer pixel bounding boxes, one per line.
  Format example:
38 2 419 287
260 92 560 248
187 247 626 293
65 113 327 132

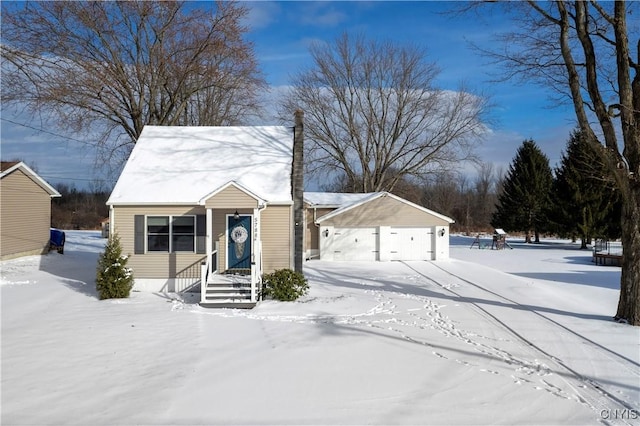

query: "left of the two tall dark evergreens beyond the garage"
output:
491 139 553 243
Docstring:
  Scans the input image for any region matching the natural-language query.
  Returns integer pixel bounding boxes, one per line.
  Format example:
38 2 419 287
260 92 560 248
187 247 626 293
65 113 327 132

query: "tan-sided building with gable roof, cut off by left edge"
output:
0 161 60 260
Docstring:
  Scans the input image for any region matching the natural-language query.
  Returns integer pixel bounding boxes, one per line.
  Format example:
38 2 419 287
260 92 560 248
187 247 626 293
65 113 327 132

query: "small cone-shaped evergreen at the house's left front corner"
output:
96 234 133 300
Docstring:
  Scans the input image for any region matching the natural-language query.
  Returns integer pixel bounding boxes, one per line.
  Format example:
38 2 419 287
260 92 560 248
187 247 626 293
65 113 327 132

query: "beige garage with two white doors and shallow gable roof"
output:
305 192 454 261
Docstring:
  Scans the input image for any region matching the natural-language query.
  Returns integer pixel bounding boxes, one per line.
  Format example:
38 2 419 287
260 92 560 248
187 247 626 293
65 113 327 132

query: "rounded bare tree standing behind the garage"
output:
280 34 487 192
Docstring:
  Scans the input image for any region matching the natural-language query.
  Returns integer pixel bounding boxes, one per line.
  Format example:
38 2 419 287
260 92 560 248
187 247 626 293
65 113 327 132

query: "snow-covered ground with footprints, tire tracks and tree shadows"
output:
0 231 640 425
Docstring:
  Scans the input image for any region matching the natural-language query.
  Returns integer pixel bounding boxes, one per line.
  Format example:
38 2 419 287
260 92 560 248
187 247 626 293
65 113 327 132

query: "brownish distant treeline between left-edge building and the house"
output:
51 184 109 229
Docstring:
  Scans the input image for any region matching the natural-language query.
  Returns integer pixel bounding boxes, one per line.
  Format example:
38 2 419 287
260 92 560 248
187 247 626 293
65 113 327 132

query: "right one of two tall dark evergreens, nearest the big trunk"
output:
553 130 621 249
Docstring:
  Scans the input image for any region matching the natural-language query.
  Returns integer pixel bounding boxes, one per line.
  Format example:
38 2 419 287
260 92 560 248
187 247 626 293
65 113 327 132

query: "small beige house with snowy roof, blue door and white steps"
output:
107 126 294 307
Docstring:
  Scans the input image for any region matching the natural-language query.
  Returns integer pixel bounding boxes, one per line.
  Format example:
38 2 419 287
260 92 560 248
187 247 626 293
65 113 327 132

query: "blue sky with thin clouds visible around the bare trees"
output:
0 1 575 187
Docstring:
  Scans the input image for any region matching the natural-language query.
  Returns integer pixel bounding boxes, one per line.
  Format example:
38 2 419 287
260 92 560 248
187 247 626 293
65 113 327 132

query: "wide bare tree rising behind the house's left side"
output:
1 1 265 170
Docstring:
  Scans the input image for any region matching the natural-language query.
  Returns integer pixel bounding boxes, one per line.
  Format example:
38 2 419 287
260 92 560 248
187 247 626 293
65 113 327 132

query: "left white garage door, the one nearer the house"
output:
328 228 378 260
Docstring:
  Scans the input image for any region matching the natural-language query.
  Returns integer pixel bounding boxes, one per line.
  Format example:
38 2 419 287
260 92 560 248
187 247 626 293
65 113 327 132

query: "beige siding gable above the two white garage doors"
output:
322 197 449 228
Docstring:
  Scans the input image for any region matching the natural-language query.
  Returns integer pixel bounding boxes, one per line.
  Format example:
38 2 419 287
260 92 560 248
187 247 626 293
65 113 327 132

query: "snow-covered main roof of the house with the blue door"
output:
107 126 293 205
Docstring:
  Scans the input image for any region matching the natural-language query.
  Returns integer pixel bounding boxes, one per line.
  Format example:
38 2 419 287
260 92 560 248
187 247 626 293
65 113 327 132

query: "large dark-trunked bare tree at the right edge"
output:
470 0 640 325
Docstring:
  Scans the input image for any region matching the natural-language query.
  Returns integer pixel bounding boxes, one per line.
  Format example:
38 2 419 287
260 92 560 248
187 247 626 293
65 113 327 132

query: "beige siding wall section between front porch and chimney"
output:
260 206 293 273
